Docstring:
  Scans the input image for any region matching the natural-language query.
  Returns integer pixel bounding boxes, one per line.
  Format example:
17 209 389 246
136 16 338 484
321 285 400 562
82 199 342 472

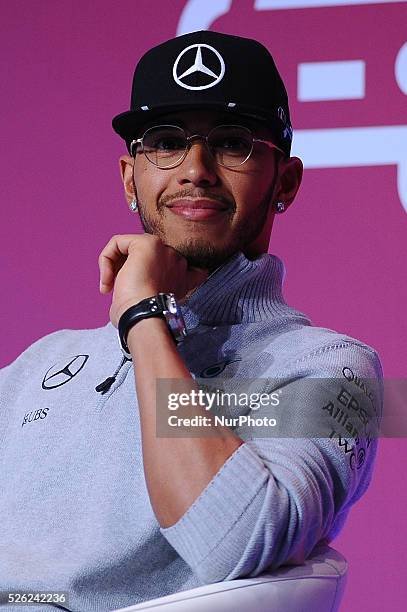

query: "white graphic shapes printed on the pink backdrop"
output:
177 0 407 212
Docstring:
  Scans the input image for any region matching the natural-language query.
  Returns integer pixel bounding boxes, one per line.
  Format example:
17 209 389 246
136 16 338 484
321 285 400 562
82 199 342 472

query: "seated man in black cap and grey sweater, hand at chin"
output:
0 32 382 611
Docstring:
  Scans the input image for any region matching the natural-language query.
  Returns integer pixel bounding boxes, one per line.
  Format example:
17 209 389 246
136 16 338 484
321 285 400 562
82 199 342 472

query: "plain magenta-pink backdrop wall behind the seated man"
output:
0 0 407 612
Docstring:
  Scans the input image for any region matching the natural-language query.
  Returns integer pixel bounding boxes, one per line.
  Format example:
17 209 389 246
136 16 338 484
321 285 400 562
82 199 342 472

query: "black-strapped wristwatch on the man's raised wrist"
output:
118 293 188 360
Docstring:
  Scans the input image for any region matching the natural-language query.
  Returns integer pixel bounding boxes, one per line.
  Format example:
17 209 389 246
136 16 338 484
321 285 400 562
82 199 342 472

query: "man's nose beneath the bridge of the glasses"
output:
178 137 218 187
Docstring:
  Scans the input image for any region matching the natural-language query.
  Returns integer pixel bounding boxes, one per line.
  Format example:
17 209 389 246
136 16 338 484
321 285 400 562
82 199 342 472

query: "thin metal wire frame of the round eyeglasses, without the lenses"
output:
130 123 286 170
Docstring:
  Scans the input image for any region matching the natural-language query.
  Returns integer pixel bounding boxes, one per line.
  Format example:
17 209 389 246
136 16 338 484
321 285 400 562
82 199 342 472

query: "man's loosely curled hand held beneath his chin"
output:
99 234 207 327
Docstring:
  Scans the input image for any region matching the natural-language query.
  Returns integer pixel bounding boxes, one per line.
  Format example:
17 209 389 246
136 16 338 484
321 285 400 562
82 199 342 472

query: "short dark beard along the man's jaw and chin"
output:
138 176 277 273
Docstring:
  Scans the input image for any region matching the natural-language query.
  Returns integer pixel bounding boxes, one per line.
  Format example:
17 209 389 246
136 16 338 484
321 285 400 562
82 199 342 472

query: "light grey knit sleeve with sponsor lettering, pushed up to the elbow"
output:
161 341 383 583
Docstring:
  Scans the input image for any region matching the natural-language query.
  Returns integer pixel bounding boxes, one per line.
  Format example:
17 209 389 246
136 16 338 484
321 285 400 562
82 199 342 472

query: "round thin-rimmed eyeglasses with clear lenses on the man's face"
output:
130 125 285 168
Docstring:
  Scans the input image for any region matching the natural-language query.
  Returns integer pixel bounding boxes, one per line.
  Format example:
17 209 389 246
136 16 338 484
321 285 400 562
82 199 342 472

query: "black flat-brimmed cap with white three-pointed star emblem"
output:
112 30 292 156
